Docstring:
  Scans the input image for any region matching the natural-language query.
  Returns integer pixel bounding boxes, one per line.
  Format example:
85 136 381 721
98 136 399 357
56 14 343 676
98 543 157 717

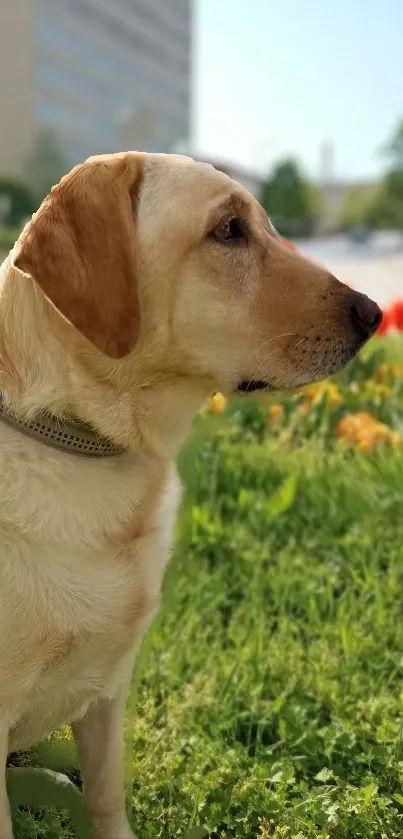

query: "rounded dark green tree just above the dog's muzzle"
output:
260 158 319 236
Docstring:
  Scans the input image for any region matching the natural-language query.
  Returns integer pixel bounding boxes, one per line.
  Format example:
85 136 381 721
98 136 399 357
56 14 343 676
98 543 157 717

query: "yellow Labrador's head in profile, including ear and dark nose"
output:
13 152 381 404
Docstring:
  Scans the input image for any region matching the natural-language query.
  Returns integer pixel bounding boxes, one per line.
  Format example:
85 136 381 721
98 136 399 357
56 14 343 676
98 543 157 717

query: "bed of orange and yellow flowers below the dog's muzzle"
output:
207 342 403 452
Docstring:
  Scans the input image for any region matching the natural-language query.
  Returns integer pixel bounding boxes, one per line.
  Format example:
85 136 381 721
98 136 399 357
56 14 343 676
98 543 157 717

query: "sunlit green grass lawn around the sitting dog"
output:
7 340 403 839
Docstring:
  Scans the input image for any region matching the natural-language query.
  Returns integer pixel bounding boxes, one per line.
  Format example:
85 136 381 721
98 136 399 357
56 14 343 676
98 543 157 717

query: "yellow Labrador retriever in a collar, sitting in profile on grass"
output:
0 152 381 839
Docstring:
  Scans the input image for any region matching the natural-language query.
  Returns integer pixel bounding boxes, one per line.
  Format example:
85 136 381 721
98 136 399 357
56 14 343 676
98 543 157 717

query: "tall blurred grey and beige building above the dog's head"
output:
0 0 191 173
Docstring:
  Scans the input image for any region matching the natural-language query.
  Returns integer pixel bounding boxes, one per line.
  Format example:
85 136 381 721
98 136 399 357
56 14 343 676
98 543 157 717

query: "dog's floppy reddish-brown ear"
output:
13 153 144 358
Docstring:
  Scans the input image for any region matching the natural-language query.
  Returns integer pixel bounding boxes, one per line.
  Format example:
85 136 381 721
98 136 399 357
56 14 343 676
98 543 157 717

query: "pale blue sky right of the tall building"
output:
193 0 403 179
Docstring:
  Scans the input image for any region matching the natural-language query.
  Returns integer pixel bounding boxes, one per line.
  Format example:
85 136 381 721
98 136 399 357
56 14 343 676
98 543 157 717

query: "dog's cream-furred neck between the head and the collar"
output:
0 260 215 459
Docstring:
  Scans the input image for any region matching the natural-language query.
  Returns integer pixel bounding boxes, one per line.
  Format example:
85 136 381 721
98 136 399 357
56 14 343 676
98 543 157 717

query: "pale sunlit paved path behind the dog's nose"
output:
299 234 403 306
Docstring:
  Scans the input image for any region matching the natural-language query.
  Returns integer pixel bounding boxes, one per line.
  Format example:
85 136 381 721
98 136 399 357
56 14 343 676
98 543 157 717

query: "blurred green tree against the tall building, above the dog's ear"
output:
26 127 69 204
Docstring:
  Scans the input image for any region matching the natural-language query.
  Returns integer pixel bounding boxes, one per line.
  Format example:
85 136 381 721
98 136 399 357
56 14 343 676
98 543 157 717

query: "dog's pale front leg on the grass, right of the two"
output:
72 692 135 839
